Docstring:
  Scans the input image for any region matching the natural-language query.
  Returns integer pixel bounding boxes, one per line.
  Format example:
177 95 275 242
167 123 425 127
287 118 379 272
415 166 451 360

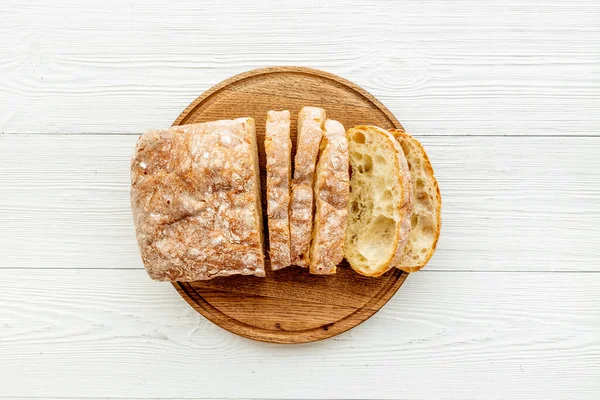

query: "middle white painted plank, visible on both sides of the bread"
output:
0 135 600 271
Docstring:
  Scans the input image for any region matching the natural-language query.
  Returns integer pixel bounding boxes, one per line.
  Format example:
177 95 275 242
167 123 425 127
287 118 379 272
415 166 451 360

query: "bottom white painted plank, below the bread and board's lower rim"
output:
0 270 600 399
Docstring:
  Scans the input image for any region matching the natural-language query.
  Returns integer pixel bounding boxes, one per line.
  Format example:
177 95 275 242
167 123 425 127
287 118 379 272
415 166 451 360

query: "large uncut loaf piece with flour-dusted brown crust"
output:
131 118 265 281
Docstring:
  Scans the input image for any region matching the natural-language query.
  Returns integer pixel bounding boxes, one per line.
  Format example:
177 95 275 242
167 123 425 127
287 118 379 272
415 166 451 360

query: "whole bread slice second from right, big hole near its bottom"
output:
344 126 412 276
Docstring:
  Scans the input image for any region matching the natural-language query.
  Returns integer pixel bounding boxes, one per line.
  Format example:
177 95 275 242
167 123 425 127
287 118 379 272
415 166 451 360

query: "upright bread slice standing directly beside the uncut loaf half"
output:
265 110 292 270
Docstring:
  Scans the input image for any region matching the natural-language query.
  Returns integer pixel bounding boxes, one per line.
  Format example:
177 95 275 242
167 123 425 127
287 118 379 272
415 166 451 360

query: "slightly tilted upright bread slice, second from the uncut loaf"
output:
290 107 326 267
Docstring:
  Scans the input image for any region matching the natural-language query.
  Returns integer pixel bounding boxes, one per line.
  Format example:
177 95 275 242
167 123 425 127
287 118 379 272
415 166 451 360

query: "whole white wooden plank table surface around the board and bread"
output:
0 0 600 399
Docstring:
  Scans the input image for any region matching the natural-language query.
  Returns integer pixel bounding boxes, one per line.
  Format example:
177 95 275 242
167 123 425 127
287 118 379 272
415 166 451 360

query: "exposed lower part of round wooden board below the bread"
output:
173 265 408 344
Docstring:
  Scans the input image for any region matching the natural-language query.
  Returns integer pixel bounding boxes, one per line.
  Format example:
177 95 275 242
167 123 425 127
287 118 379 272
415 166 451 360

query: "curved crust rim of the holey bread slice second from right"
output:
345 125 413 277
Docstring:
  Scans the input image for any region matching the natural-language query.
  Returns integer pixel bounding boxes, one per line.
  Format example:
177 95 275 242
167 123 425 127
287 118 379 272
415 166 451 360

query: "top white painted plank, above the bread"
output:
0 0 600 135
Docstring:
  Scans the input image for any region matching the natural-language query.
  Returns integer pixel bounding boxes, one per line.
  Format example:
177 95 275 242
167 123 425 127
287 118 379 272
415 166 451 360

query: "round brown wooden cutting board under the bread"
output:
173 67 407 343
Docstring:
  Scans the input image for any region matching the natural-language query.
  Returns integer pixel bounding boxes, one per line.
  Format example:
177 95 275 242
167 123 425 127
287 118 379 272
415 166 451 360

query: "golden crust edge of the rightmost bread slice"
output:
389 129 442 272
